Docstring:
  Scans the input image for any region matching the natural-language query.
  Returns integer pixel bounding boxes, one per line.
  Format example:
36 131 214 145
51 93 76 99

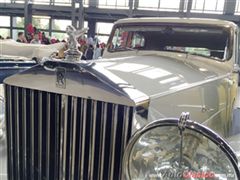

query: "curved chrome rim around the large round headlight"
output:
122 118 240 179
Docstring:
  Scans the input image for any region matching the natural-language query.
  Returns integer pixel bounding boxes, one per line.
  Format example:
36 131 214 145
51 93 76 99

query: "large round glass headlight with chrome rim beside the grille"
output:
123 113 240 180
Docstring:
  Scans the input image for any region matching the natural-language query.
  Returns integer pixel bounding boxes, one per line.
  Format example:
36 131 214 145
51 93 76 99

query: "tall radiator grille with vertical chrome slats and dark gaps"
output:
5 85 133 180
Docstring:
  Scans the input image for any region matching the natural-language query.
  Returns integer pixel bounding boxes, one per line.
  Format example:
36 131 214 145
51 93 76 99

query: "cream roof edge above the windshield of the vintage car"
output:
115 17 237 28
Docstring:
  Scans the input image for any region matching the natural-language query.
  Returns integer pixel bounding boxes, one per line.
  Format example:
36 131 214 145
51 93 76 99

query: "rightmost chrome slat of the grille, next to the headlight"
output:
119 106 130 179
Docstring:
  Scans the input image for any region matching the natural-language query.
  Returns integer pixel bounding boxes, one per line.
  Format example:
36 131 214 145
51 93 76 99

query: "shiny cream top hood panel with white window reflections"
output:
95 52 231 97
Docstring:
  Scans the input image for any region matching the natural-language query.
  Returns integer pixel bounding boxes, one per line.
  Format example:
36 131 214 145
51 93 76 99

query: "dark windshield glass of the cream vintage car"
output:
108 25 231 59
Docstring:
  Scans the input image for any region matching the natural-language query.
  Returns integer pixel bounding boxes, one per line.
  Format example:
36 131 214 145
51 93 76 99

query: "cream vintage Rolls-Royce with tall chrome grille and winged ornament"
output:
1 18 240 180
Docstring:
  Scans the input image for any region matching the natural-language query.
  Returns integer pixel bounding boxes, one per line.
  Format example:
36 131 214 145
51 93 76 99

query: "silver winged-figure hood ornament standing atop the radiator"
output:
64 26 88 61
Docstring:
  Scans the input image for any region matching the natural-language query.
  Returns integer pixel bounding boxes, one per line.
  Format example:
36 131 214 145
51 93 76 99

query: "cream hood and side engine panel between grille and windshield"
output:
96 51 237 136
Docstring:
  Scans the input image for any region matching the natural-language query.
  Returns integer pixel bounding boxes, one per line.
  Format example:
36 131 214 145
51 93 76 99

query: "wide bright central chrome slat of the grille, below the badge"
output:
59 95 68 180
